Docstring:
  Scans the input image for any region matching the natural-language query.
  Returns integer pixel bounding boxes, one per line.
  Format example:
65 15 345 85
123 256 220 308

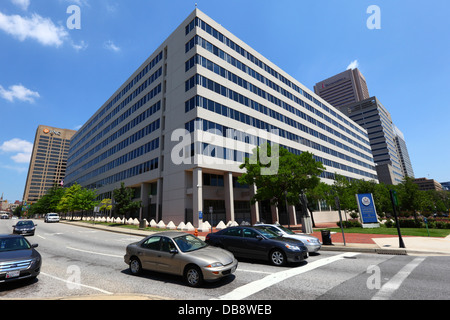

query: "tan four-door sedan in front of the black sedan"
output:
124 231 238 287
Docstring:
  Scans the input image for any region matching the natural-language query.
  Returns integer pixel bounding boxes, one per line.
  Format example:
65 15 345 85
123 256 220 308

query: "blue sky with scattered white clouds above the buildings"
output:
0 0 450 201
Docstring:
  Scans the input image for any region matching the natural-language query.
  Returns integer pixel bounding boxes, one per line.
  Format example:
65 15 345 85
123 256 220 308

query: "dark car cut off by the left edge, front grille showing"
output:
0 235 42 283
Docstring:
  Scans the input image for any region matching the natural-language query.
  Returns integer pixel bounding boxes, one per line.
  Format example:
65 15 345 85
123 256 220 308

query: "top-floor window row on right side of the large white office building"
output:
186 17 367 136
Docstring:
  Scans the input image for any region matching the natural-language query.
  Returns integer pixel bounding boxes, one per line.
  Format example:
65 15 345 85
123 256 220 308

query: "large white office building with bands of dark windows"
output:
66 9 377 226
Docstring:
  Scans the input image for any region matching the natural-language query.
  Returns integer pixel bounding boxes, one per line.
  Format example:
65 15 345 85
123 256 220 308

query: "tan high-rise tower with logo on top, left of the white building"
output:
23 125 76 202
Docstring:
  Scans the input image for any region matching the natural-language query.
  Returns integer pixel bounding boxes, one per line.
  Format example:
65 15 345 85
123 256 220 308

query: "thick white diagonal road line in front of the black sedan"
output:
213 253 359 300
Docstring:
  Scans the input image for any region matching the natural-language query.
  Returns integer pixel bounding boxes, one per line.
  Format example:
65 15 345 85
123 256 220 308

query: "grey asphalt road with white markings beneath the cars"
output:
0 220 450 301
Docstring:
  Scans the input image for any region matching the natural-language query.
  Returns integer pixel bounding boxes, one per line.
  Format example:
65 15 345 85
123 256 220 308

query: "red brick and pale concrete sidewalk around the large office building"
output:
61 220 450 255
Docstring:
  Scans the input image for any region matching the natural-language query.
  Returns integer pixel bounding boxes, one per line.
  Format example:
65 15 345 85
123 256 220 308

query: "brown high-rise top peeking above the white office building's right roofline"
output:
314 69 370 108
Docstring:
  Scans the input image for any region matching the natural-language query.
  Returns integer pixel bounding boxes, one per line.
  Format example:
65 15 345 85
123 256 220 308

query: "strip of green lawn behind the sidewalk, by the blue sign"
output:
320 226 450 238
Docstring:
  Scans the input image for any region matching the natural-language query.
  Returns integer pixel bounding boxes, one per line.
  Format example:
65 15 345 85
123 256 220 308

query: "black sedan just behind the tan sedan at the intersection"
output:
206 226 308 266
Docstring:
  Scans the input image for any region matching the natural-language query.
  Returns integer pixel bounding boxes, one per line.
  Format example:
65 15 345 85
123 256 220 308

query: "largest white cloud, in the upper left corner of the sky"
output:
0 12 69 47
